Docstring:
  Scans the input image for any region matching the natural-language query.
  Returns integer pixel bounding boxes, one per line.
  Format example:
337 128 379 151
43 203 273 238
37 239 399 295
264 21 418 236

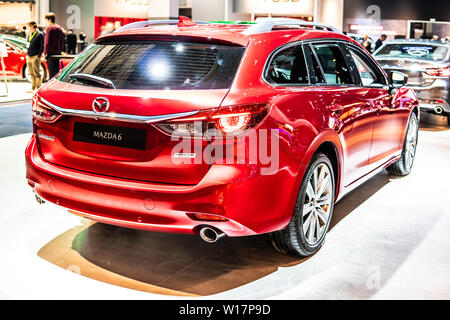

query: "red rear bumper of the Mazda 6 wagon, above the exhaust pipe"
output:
25 136 296 237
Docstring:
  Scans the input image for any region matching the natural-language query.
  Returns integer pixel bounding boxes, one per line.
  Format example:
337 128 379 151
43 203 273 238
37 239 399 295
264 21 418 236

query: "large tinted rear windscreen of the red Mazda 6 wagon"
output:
58 42 245 90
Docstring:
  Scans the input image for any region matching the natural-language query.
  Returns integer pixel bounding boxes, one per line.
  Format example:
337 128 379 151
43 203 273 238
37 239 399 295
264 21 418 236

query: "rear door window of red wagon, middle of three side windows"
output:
313 44 355 85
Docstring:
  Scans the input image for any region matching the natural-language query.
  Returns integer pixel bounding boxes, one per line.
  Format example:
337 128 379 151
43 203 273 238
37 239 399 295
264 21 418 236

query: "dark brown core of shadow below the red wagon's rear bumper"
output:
77 223 302 296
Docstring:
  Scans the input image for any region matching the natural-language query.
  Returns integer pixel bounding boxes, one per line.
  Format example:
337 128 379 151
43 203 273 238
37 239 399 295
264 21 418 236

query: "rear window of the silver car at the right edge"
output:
375 43 449 61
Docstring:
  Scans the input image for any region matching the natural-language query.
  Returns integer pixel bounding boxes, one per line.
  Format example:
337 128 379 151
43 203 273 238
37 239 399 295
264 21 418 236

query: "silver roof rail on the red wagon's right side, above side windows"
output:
242 18 341 36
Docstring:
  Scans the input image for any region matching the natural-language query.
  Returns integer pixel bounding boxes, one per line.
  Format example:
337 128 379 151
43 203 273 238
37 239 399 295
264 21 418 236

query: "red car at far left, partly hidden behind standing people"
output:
0 35 48 82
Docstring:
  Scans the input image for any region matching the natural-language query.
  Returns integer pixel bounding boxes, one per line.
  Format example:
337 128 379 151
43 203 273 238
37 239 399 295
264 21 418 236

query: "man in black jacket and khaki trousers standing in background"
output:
27 21 44 91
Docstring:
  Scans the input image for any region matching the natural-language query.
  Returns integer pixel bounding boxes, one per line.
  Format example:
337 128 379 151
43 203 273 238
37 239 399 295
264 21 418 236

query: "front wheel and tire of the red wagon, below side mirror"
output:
386 112 419 177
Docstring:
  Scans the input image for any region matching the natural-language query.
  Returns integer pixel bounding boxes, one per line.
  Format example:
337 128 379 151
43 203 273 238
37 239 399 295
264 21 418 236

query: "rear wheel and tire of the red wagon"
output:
269 153 336 257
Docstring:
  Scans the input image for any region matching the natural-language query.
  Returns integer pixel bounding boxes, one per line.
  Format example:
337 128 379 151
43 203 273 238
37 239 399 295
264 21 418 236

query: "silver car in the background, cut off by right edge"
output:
373 40 450 126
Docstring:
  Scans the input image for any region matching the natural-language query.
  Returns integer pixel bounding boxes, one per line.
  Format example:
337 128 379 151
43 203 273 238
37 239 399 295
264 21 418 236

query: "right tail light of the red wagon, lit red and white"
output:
156 103 269 137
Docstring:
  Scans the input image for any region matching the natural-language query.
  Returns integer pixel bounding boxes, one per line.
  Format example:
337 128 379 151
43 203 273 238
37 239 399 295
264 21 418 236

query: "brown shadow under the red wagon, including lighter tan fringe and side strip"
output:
38 173 389 296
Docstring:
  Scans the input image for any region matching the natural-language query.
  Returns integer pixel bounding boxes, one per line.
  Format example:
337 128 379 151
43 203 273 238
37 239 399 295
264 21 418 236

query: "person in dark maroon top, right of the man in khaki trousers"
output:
44 12 64 79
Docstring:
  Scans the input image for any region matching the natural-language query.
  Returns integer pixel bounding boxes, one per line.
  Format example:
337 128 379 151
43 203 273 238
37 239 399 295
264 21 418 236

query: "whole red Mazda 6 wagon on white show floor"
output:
26 18 419 256
